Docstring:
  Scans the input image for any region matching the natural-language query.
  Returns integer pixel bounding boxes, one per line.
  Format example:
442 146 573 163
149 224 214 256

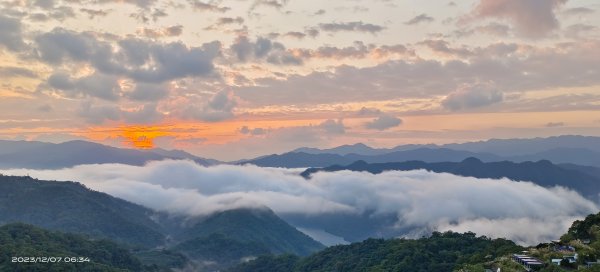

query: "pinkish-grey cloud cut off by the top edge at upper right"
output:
473 0 567 38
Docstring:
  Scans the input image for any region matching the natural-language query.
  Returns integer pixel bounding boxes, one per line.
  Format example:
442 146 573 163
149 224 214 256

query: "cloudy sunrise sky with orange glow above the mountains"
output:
0 0 600 160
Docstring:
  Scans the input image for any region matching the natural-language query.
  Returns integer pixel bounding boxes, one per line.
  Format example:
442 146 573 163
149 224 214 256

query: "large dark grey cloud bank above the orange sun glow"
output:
36 28 221 83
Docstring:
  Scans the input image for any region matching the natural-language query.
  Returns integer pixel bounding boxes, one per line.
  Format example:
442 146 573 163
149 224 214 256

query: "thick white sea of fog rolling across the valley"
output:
2 161 598 245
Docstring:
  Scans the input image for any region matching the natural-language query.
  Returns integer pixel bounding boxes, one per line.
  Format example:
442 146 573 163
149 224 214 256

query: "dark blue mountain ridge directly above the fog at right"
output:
301 158 600 200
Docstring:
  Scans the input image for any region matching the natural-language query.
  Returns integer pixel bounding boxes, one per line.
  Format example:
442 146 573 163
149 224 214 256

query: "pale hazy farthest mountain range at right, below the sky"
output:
245 136 600 168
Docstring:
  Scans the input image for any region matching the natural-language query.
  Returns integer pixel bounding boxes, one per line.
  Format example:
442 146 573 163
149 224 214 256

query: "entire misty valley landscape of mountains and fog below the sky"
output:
0 136 600 272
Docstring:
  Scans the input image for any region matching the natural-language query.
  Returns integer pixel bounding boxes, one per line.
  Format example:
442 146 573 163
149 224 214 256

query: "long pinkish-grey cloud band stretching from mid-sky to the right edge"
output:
234 40 600 106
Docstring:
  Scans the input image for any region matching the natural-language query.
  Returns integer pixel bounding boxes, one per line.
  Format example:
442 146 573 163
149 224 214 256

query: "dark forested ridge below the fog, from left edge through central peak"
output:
0 175 324 270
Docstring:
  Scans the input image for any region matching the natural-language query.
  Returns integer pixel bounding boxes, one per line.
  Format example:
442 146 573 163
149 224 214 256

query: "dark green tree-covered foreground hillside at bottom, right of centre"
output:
231 232 522 272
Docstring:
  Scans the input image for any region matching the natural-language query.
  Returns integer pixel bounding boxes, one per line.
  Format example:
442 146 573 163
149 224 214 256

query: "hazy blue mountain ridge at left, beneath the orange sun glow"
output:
0 140 218 169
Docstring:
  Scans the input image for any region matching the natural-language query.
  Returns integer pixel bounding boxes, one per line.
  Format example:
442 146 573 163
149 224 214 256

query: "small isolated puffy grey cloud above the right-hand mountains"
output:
442 84 504 111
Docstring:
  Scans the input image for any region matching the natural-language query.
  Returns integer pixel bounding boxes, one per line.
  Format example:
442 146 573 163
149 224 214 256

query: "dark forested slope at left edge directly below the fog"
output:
0 175 164 247
